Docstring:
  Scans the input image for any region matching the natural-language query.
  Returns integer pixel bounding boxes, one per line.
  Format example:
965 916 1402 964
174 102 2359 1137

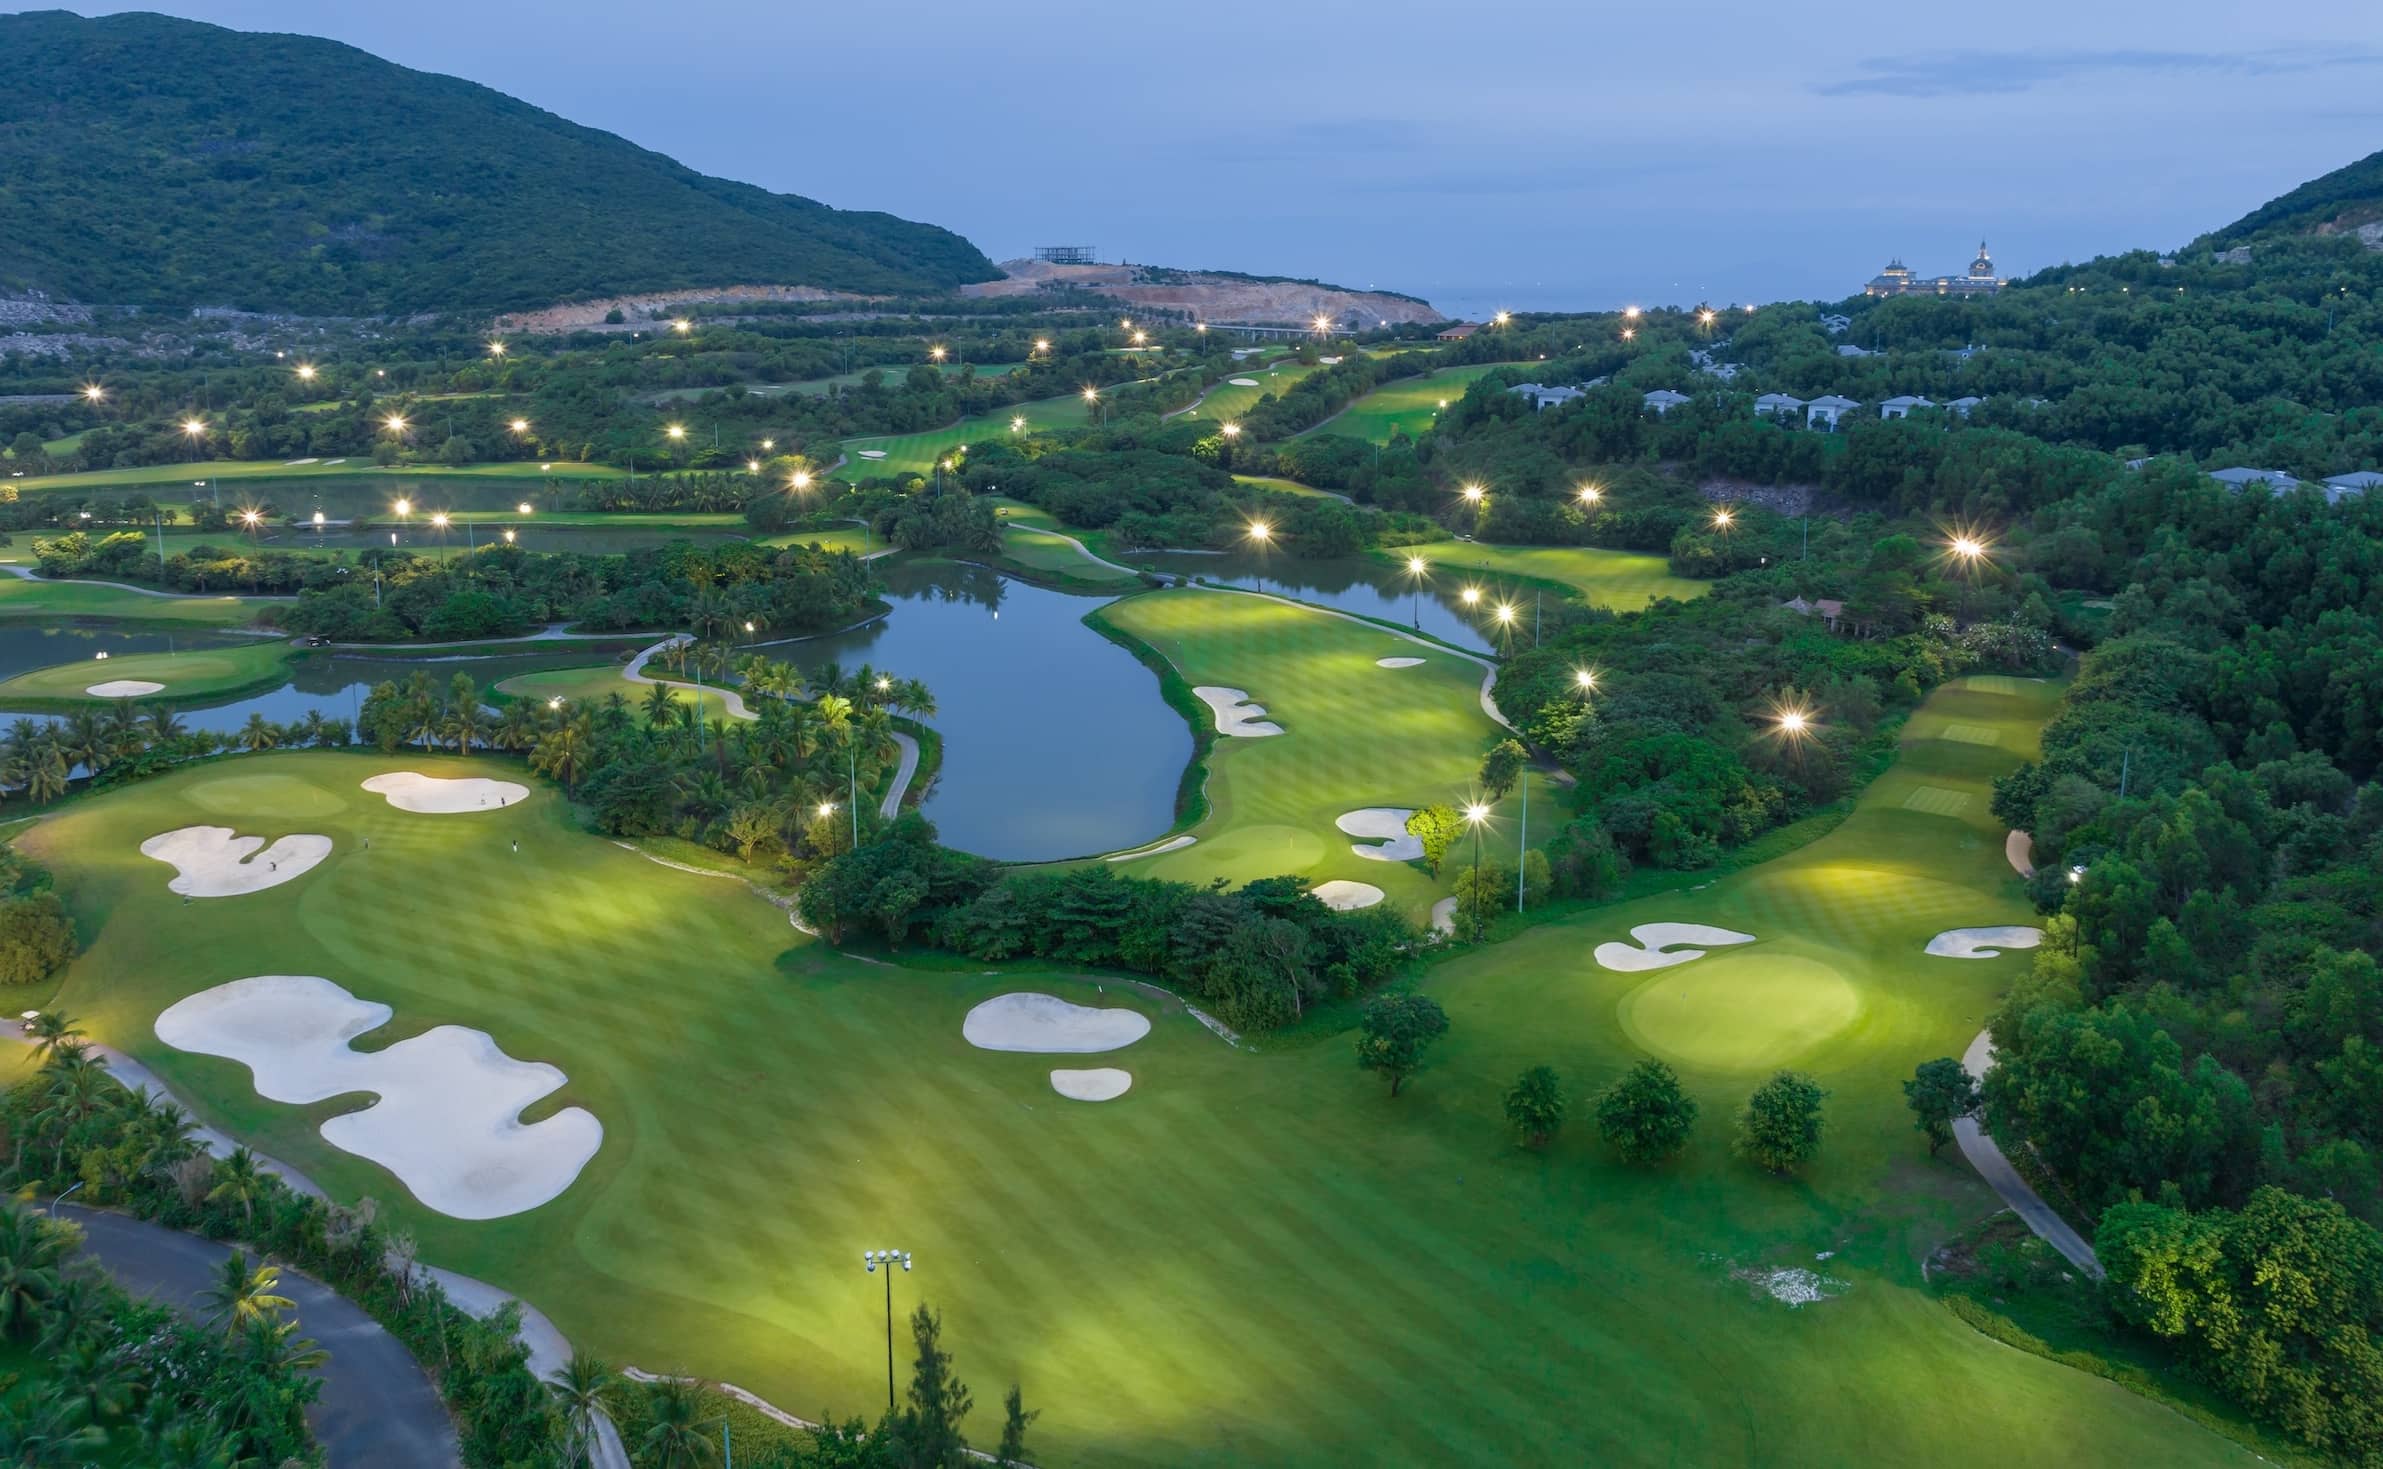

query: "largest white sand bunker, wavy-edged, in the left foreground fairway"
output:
157 975 603 1219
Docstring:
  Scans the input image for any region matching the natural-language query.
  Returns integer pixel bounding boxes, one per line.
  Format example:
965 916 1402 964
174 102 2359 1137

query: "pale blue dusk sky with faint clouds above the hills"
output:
46 0 2383 315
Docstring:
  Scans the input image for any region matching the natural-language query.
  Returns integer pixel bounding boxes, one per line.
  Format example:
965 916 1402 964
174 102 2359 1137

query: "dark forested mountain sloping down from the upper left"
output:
0 10 1001 315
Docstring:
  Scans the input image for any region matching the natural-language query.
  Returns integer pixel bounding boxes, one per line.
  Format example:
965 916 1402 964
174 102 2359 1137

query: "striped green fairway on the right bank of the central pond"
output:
1101 587 1506 906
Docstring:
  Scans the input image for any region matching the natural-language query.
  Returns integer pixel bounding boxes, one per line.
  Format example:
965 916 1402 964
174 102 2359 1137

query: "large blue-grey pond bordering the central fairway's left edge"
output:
763 563 1192 861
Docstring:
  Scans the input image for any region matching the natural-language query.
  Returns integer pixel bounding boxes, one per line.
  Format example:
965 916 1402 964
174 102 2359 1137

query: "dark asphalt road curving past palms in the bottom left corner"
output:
60 1204 462 1469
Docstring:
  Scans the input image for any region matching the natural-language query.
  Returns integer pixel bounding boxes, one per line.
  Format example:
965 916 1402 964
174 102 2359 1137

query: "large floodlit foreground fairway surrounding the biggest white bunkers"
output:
19 686 2242 1469
